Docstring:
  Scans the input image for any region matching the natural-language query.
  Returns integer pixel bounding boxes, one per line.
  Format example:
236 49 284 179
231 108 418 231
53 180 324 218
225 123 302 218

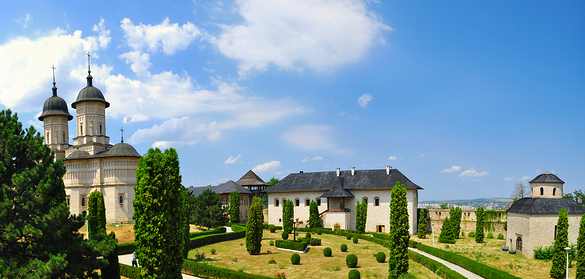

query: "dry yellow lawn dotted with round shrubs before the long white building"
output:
189 230 440 279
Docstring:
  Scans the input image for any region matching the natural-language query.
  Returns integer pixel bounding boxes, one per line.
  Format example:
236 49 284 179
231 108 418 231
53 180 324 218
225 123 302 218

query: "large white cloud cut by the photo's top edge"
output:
211 0 392 76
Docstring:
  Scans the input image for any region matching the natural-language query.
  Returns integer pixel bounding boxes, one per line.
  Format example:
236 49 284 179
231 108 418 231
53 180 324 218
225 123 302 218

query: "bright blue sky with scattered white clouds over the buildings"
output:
0 0 585 201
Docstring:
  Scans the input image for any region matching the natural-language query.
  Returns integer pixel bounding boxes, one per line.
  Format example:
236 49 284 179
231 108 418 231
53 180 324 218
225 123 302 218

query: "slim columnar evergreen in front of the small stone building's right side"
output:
550 208 569 278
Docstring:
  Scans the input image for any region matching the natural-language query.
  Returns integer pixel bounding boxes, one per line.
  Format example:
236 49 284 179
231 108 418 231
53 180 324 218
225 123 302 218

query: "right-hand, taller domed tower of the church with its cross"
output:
71 53 110 155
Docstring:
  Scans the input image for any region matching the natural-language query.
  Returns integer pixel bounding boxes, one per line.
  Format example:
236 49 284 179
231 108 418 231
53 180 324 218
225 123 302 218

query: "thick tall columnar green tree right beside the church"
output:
133 148 185 278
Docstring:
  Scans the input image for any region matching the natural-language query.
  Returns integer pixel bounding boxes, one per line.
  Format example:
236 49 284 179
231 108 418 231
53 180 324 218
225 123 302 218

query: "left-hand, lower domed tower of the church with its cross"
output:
39 67 73 159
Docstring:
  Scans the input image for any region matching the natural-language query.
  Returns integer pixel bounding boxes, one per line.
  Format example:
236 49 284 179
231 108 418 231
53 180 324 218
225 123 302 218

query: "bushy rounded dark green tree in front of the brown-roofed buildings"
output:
193 189 227 229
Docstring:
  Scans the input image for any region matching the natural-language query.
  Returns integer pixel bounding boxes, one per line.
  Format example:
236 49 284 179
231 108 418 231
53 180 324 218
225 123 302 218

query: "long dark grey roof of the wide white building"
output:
265 169 423 192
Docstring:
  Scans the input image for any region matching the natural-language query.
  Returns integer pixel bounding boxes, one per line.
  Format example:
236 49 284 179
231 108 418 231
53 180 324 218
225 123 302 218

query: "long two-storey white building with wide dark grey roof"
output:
265 166 422 234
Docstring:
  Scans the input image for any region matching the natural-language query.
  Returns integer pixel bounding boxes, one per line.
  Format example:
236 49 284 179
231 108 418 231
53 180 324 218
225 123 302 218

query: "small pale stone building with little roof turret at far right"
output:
506 172 585 258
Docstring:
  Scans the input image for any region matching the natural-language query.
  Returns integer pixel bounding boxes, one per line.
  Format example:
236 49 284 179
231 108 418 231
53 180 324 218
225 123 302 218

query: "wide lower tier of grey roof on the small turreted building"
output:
507 198 585 214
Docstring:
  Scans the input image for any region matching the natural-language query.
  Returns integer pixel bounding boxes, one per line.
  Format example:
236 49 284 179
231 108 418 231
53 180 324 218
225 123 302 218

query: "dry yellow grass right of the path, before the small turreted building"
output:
411 232 576 278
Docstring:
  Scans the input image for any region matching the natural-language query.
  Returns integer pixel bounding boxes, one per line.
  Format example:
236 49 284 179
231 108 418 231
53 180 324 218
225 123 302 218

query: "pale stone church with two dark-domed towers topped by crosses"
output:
39 58 141 223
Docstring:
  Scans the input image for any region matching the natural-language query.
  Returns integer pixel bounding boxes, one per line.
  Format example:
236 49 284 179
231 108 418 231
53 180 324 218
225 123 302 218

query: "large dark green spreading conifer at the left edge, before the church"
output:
0 110 114 278
